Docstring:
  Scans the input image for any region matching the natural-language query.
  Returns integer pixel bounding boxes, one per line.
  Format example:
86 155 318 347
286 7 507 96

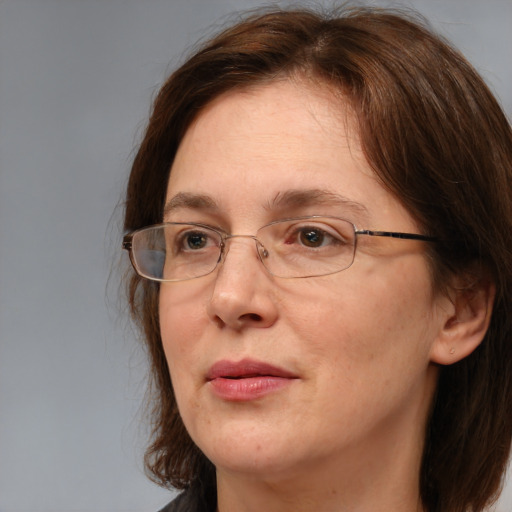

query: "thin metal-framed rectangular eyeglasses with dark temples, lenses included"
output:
123 215 436 282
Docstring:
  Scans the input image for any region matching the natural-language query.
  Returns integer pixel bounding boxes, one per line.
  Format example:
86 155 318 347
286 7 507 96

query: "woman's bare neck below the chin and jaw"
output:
217 428 423 512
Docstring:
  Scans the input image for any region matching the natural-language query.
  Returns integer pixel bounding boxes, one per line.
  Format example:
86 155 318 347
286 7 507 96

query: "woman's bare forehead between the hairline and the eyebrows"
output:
167 81 414 230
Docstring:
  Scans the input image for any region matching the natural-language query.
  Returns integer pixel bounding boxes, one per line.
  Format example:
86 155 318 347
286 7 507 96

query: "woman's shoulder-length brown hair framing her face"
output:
125 9 512 512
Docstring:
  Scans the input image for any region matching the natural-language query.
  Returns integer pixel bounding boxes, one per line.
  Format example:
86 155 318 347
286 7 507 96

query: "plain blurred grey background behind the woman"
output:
0 0 512 512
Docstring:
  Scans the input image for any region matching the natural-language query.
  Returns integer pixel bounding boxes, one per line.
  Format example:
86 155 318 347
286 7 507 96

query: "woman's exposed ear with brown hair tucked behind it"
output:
430 278 496 365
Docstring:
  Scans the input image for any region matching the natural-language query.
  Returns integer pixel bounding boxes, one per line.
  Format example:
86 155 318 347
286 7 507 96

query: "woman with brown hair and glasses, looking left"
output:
124 5 512 512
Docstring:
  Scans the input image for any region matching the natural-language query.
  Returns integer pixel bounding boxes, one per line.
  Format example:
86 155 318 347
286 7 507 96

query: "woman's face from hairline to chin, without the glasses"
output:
159 81 442 479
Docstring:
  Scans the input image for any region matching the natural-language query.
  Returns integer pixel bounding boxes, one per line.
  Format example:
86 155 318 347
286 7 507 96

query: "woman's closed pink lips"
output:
206 359 297 402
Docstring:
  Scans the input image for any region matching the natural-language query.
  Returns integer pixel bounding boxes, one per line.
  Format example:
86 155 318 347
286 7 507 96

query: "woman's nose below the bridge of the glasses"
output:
207 235 278 331
